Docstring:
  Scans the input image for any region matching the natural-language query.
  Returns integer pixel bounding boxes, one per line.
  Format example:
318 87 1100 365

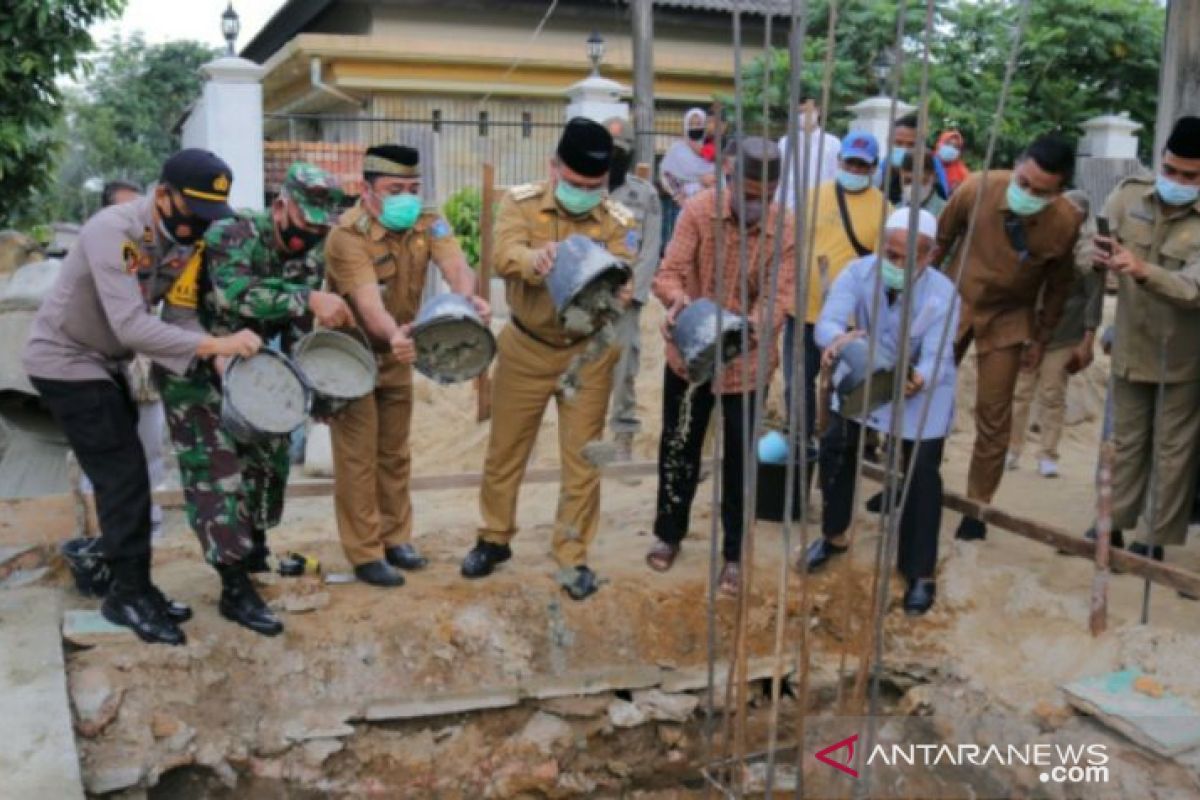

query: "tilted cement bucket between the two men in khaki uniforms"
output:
412 294 496 384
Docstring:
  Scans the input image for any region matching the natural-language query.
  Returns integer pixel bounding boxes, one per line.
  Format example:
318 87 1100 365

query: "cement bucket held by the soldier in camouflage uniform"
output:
292 330 379 417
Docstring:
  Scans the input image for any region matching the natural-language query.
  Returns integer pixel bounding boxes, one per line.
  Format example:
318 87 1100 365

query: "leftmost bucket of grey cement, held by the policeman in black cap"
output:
221 349 312 444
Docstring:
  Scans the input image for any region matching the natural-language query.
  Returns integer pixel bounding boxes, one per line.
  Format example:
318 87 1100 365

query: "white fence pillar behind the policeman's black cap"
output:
182 56 264 209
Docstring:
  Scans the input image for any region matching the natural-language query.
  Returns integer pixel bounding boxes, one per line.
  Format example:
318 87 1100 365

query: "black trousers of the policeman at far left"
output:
31 375 150 561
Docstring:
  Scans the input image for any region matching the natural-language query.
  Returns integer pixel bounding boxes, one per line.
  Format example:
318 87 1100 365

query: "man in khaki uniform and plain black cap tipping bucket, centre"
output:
462 118 634 600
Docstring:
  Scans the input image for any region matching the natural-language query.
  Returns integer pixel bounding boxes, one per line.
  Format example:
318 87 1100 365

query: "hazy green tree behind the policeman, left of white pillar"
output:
42 36 217 219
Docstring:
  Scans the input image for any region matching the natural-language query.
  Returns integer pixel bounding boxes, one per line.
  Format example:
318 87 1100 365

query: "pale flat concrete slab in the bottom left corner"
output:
0 589 84 800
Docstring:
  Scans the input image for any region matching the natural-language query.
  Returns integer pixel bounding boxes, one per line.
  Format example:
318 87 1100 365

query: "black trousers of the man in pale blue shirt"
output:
821 415 946 579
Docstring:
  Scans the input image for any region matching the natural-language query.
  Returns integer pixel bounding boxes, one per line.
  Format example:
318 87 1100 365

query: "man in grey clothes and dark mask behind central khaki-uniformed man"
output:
605 116 662 459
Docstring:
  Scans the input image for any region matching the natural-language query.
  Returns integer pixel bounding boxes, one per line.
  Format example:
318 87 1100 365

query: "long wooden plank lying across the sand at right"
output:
863 463 1200 595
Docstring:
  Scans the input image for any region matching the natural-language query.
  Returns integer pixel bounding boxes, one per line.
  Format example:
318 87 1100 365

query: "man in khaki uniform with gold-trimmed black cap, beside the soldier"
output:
325 145 490 587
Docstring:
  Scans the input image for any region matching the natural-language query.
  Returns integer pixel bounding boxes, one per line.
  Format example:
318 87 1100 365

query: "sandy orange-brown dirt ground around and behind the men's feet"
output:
60 298 1200 796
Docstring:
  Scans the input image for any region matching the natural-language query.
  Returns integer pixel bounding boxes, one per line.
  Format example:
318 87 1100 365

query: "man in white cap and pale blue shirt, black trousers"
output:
800 209 959 614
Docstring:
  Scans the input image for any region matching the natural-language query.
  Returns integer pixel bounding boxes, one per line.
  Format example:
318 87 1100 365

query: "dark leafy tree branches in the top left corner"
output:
0 0 125 227
